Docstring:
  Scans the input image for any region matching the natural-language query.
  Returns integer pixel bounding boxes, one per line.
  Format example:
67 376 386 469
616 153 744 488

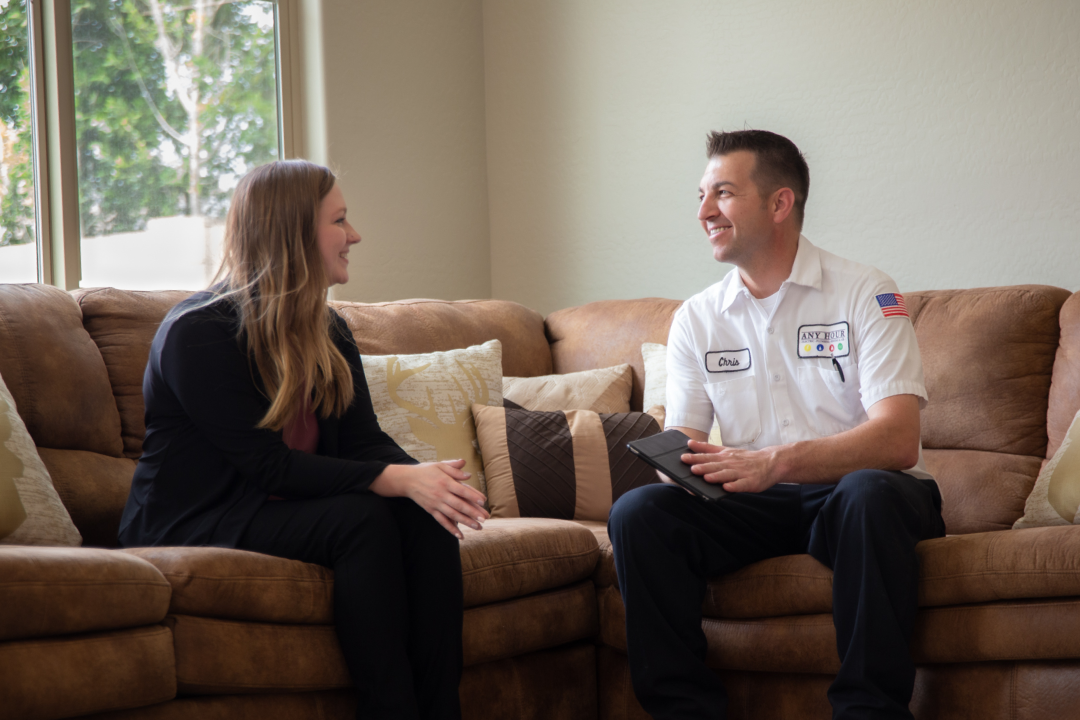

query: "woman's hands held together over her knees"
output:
370 460 488 540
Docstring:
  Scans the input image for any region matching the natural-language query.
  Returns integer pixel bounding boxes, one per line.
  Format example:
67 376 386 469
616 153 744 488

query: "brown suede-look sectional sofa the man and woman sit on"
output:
0 285 1080 720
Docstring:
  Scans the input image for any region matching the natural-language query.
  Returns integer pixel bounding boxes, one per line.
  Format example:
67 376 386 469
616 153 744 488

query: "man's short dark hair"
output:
705 130 810 228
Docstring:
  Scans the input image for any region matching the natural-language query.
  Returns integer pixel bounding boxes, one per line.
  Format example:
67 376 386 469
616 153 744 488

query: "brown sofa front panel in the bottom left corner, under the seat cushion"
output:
0 625 176 718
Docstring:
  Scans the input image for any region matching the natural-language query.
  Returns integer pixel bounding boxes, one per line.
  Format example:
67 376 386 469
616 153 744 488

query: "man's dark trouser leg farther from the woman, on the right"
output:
808 470 945 720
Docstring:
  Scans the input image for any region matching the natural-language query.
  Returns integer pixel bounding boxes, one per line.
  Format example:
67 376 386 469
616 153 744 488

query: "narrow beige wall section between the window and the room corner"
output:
313 0 491 302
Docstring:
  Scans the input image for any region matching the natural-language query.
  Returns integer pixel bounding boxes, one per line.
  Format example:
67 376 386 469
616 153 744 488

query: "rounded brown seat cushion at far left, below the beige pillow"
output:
0 547 170 643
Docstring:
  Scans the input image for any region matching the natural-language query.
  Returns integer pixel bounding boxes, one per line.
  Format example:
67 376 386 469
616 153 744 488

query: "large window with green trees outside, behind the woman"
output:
0 0 286 289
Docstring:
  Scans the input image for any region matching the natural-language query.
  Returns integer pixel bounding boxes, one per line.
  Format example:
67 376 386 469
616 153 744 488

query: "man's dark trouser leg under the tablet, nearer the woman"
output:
608 485 802 720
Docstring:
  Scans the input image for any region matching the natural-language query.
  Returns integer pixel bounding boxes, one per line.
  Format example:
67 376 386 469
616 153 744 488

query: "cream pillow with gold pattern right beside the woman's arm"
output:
362 340 502 492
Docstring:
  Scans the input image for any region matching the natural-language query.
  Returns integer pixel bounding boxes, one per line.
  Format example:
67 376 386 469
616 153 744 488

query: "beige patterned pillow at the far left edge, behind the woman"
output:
0 378 82 547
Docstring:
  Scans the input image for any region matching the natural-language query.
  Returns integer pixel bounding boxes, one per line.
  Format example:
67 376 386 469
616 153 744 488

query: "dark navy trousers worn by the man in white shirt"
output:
608 471 945 720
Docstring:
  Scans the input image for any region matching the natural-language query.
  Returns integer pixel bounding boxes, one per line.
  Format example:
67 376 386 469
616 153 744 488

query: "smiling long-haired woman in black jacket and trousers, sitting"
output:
120 160 487 720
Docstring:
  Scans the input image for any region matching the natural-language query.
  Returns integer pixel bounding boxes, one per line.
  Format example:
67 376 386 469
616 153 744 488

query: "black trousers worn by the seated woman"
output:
240 492 462 720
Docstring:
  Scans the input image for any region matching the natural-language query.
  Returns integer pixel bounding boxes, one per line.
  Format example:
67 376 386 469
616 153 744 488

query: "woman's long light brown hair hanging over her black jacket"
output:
215 160 354 430
